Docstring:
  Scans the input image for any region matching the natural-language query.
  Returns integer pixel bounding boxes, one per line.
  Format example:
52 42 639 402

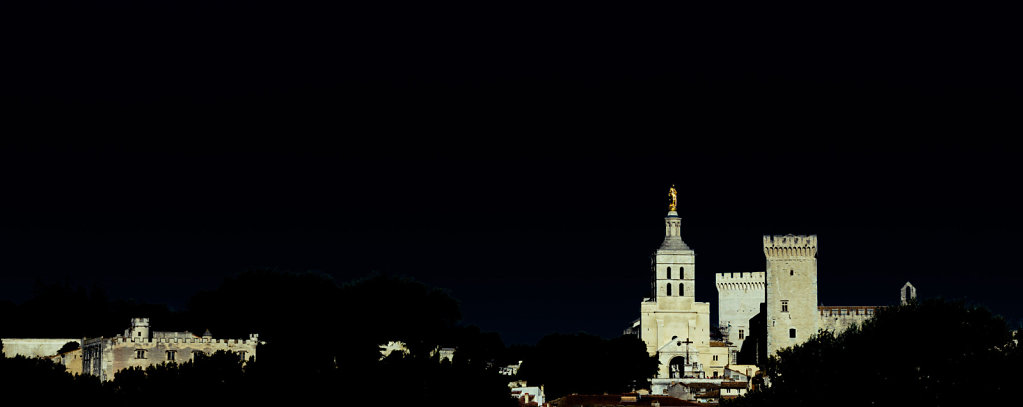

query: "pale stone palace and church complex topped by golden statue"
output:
625 187 916 394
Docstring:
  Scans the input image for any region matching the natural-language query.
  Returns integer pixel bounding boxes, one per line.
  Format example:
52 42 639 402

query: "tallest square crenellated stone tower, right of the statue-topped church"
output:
764 234 819 355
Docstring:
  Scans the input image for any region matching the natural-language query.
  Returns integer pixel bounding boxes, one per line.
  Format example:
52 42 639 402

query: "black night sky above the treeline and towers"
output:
0 2 1023 343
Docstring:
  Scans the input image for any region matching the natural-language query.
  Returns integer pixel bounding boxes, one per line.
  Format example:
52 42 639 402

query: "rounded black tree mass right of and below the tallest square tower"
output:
729 300 1023 406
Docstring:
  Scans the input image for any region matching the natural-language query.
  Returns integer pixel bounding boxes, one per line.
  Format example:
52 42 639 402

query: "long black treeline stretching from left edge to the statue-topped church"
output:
0 271 657 406
